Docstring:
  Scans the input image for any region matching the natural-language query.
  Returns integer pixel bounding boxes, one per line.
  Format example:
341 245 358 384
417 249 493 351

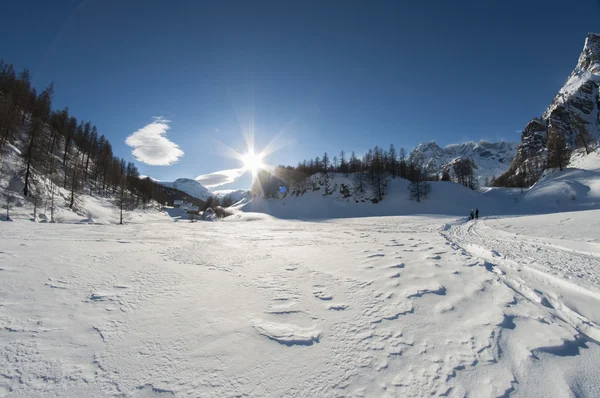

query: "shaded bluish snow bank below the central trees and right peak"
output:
243 149 600 220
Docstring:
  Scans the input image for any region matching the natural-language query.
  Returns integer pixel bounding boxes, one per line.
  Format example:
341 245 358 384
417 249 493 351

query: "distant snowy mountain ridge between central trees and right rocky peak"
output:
410 141 518 184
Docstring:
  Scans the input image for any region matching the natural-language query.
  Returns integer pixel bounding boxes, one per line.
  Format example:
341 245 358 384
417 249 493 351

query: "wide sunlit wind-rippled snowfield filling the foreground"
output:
0 217 600 397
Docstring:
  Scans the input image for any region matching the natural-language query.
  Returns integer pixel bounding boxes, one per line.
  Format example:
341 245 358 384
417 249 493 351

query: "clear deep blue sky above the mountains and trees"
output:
0 0 600 188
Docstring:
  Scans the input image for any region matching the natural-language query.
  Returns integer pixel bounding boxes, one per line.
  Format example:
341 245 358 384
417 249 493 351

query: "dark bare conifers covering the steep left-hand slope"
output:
0 61 176 221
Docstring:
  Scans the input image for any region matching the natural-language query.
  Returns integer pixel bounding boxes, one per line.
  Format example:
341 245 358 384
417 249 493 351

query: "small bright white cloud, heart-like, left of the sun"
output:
125 117 183 166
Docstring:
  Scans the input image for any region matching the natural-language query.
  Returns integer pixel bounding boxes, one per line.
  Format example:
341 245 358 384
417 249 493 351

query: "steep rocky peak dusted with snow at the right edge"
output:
501 33 600 186
